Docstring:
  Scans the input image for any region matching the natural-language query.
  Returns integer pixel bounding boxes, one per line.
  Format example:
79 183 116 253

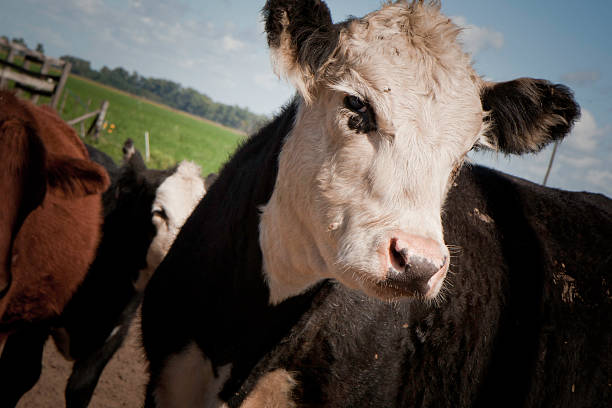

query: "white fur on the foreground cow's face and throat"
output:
260 3 485 303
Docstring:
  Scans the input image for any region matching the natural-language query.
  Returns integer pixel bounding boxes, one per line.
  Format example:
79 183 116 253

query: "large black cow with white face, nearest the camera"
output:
142 0 612 408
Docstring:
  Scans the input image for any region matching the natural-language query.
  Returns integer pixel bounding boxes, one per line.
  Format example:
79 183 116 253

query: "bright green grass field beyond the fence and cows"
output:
58 75 246 176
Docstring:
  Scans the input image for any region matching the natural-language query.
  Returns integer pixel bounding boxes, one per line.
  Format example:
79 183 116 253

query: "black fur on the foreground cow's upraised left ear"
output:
262 0 339 73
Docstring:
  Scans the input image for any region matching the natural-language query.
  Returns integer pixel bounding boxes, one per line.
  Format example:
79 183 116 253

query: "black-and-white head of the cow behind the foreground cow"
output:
113 148 206 291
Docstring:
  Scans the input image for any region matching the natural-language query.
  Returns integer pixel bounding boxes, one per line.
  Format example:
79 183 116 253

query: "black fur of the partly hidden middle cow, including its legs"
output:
0 146 176 407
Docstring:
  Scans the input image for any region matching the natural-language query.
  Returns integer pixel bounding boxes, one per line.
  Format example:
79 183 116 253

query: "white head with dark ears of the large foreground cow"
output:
260 0 579 303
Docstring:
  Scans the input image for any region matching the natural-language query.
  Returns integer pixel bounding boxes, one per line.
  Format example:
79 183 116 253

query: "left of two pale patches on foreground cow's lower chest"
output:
154 343 231 408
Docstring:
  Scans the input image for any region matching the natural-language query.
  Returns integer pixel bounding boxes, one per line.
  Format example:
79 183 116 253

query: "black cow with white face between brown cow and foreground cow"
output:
0 142 205 407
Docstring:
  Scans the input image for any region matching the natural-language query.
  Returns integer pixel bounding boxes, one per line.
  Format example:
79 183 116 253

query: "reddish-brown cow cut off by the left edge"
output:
0 92 109 348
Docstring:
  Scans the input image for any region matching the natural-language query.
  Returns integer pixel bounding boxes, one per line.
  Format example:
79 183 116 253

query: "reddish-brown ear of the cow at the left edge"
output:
46 155 110 197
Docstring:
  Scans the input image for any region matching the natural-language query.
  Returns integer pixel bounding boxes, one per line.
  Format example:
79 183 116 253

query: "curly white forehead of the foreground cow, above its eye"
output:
329 3 480 94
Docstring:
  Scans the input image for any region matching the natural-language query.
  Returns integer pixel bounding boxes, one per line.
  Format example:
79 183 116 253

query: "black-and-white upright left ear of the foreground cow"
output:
262 0 339 102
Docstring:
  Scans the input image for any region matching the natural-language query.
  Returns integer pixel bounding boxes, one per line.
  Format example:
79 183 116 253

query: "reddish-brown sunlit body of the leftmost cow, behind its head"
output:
0 98 108 330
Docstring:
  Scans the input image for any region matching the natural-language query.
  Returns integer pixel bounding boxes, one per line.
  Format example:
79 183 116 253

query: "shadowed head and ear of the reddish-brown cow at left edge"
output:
0 92 109 297
